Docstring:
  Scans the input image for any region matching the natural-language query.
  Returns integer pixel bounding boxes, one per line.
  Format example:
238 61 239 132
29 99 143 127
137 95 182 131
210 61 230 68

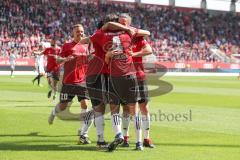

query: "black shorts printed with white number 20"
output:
60 84 89 103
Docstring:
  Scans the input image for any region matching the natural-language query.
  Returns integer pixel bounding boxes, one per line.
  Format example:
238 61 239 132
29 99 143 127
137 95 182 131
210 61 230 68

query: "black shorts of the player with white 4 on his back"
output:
109 75 137 105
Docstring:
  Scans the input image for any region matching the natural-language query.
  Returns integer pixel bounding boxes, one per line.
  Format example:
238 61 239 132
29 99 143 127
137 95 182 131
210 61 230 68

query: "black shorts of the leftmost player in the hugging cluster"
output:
86 74 109 107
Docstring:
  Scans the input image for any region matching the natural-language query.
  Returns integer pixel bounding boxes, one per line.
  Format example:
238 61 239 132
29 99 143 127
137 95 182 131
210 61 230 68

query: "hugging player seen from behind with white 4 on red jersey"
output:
102 27 143 151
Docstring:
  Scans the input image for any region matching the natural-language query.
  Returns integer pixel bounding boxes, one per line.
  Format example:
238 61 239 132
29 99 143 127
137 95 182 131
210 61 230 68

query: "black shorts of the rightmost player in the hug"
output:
137 80 149 103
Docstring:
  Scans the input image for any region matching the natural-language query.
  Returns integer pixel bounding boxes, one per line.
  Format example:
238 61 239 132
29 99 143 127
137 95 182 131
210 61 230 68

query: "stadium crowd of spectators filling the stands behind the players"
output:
0 0 240 62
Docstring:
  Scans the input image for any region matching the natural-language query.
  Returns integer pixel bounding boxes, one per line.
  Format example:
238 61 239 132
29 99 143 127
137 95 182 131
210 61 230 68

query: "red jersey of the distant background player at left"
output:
43 47 61 72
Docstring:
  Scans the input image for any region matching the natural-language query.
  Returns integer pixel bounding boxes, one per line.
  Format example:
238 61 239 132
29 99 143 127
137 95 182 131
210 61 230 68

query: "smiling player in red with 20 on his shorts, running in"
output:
48 24 92 144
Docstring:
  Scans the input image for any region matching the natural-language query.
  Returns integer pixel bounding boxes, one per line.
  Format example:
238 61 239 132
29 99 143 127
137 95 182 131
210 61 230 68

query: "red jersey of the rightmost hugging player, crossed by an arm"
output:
132 37 148 80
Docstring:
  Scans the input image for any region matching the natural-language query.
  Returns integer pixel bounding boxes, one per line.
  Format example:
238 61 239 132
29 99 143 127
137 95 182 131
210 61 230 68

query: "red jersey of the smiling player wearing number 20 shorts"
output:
60 41 87 84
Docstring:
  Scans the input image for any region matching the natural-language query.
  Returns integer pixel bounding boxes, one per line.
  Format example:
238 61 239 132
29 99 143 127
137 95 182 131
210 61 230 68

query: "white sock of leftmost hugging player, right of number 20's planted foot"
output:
94 112 104 142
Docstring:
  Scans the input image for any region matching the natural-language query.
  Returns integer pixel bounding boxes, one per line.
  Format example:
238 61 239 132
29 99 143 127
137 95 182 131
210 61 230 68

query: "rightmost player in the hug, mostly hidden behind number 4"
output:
119 13 154 148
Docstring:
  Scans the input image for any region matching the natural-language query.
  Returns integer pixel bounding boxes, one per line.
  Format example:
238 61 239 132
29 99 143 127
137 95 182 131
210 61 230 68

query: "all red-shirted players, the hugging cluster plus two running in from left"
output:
33 13 154 151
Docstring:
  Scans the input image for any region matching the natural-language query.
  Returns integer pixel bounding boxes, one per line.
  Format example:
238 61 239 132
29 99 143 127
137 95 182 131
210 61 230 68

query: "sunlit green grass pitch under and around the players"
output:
0 76 240 160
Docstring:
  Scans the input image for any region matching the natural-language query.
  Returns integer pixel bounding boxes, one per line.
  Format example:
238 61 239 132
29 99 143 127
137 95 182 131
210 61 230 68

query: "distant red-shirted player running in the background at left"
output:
43 38 61 99
